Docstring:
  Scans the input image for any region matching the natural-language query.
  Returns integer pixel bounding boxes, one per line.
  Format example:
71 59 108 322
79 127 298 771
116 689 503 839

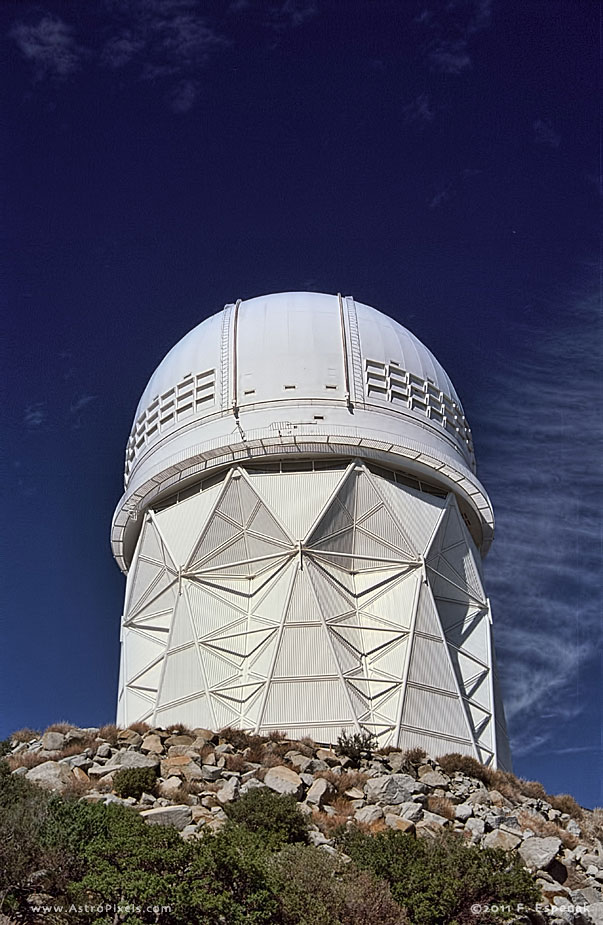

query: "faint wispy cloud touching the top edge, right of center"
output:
415 0 492 74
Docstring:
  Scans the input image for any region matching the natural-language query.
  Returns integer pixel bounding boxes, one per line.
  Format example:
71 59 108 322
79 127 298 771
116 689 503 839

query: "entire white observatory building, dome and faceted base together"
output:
112 292 511 768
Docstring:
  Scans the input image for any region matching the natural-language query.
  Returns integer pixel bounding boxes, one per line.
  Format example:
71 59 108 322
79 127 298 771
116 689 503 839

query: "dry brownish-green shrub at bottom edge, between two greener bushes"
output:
270 845 408 925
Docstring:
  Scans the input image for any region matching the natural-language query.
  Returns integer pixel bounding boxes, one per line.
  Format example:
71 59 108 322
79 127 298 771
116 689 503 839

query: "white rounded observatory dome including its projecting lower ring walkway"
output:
112 292 493 569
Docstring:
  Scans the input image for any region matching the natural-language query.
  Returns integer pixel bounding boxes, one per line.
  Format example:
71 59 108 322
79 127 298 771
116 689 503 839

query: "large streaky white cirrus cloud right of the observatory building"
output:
476 288 603 754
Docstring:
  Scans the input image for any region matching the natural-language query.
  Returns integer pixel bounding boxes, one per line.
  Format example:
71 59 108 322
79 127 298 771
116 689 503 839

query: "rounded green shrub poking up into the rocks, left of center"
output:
224 787 308 850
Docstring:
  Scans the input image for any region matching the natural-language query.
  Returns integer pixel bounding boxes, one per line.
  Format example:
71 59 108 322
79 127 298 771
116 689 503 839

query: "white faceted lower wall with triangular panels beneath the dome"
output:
118 460 510 767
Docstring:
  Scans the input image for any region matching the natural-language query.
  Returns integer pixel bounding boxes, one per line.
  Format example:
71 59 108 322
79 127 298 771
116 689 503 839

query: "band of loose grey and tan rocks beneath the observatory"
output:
4 724 603 925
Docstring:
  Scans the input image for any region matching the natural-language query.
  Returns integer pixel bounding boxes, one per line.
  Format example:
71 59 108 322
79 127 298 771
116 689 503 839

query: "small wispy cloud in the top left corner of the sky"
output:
9 15 85 80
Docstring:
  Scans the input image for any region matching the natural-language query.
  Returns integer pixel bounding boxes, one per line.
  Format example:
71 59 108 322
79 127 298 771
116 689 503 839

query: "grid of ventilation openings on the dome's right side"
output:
365 360 473 454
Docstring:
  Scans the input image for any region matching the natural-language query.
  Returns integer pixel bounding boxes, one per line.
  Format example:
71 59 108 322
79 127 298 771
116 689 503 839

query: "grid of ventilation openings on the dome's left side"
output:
125 369 216 483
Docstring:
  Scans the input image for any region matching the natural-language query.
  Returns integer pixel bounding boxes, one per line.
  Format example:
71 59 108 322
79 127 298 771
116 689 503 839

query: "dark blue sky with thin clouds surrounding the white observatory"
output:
0 0 603 805
